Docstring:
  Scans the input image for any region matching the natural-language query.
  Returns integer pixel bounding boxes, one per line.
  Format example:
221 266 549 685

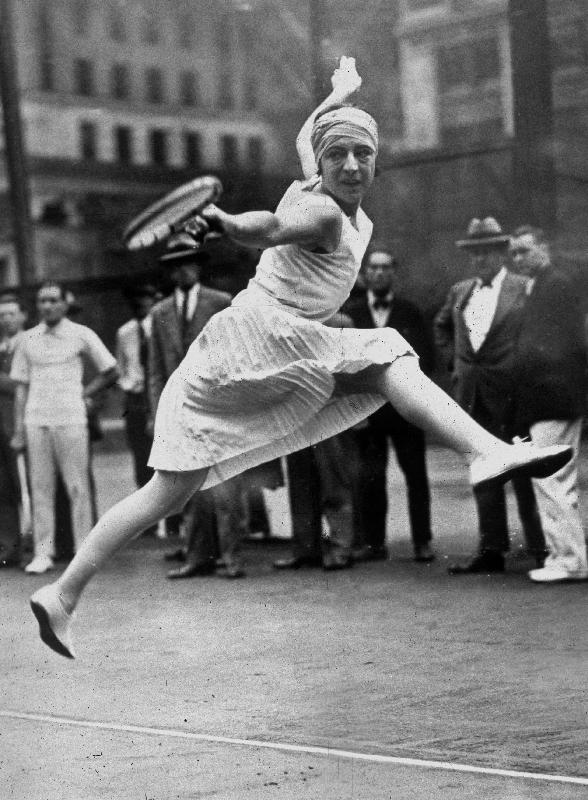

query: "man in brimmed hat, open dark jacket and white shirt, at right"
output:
435 217 545 575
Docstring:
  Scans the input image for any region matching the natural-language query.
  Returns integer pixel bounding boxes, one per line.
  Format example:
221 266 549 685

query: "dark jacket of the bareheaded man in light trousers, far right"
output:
516 268 587 429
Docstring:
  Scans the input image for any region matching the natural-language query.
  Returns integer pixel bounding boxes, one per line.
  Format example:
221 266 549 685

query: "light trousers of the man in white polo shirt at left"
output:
26 424 92 558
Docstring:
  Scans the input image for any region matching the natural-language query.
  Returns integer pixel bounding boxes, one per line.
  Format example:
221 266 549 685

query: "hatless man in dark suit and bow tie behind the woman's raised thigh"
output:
345 246 435 562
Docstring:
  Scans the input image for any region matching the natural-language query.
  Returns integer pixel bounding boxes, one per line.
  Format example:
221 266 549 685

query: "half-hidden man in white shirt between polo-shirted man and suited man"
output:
115 284 157 486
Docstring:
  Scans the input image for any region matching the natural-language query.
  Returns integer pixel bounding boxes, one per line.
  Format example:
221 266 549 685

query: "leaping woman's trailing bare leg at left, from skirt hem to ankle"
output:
56 469 207 612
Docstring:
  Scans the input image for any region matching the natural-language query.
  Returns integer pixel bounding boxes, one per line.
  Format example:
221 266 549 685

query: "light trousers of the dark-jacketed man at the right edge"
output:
530 418 588 572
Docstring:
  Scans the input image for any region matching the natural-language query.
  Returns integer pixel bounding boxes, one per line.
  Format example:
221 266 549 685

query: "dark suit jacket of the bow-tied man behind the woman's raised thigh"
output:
343 292 434 429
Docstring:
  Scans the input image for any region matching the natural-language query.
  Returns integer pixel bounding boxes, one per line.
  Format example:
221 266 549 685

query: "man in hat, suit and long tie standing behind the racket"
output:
149 233 243 579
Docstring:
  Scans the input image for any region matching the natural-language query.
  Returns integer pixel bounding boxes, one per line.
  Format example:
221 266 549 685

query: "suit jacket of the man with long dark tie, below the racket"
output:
149 285 231 411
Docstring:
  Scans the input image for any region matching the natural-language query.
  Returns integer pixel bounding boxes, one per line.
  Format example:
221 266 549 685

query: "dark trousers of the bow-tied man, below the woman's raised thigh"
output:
356 418 432 549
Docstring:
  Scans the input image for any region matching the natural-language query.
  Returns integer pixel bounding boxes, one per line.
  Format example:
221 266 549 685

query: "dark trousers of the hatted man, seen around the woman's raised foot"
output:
472 401 546 556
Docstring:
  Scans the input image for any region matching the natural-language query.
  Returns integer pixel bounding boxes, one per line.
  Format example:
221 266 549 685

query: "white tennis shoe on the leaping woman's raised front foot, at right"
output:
470 440 574 486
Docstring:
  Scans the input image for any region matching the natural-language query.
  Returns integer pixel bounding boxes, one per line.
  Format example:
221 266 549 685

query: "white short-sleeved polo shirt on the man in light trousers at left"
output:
10 319 116 426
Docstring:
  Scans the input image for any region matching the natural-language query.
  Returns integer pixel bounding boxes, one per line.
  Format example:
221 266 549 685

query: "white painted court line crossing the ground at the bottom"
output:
0 710 588 786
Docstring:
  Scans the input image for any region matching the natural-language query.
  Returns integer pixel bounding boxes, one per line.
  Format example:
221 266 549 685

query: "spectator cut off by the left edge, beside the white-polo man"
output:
0 294 26 567
